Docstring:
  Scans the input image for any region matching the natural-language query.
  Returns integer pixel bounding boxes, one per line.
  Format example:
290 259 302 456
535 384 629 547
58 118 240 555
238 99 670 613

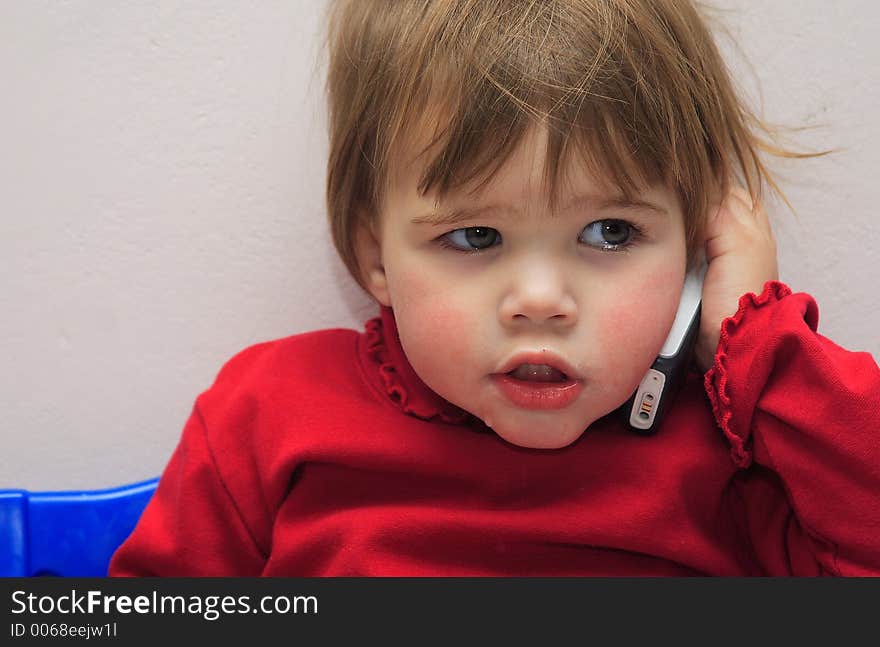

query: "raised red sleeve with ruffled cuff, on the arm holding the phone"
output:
705 281 880 576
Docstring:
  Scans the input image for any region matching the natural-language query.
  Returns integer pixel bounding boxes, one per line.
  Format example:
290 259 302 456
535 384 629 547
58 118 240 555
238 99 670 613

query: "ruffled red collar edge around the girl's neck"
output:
363 306 482 426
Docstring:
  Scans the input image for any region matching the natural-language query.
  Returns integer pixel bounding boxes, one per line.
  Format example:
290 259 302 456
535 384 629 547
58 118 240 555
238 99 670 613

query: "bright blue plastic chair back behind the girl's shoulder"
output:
0 478 159 577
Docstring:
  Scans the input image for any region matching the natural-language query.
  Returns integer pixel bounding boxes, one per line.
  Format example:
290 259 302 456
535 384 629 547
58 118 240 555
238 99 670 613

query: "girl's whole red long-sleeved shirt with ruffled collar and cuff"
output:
110 282 880 576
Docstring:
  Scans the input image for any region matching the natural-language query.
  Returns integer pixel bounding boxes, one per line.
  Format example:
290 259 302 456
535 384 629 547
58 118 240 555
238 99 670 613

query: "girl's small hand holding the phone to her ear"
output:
694 185 779 373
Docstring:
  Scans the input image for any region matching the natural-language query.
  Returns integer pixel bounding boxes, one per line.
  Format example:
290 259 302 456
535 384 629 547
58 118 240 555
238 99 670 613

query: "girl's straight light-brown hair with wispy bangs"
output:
326 0 823 289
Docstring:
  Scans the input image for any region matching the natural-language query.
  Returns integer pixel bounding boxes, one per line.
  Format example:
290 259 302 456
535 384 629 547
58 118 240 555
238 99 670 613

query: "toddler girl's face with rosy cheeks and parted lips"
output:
360 129 686 448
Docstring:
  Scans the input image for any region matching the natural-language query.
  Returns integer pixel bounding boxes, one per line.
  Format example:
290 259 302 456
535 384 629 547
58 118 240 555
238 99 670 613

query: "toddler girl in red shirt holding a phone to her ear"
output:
110 0 880 576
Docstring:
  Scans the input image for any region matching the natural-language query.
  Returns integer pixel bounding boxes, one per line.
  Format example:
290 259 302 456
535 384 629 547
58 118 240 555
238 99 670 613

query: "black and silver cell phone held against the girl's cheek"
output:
619 258 707 435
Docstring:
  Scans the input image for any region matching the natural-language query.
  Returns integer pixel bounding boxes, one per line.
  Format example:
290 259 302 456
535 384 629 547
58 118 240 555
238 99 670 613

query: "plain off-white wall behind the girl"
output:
0 0 880 489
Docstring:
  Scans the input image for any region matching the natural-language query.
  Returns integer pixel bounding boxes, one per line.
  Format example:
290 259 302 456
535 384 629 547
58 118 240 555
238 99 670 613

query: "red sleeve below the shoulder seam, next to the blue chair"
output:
109 405 266 577
